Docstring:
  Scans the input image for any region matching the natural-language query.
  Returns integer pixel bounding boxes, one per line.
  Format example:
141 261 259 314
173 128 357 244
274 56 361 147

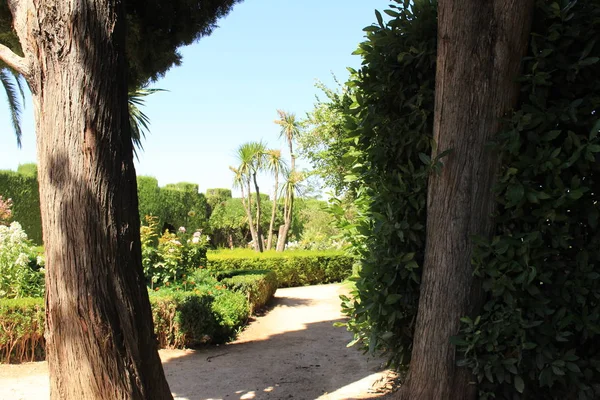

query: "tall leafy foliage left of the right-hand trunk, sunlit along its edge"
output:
338 1 438 366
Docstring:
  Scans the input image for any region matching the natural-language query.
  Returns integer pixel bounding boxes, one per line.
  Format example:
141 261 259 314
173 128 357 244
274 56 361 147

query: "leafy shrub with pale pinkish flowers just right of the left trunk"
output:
140 216 210 289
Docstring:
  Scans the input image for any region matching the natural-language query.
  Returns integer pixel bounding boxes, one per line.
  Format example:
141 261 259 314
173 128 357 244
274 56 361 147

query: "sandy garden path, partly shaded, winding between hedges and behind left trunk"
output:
0 285 388 400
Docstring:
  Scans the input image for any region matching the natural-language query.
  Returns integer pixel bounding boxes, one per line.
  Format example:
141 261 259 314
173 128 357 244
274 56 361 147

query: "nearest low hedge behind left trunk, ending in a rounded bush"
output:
0 284 250 363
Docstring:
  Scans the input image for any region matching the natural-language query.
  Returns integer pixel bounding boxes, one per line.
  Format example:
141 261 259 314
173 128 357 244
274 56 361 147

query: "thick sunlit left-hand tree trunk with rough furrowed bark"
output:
3 0 172 399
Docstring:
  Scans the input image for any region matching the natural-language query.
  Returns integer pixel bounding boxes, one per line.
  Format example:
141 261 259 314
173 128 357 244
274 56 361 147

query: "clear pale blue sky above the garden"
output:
0 0 390 197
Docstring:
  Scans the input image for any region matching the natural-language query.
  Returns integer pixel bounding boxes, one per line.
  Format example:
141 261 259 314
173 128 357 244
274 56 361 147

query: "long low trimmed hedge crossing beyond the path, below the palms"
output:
207 250 354 287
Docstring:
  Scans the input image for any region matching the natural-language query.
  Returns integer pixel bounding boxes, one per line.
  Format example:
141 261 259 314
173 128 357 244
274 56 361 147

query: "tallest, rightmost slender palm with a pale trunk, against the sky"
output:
275 110 300 251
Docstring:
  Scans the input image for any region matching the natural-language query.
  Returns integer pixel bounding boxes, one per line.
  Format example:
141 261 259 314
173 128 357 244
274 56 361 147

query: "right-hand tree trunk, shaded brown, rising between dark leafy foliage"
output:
402 0 533 400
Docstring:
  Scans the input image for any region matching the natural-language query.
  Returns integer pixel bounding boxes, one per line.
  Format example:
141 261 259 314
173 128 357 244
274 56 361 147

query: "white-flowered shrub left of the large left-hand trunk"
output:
0 222 44 298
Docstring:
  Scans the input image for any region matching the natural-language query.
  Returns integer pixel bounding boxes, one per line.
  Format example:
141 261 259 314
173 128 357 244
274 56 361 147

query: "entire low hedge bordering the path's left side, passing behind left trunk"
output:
0 270 277 363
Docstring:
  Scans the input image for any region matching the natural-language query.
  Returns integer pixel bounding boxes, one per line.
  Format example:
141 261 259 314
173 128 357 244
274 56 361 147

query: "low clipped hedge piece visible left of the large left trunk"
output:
0 298 45 363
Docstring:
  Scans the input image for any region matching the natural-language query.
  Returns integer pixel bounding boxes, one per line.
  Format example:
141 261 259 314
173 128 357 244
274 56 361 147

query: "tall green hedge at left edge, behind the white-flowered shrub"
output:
0 171 42 244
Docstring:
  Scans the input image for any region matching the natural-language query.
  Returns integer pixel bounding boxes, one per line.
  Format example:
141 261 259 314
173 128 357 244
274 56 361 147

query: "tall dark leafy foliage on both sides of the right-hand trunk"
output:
332 0 600 399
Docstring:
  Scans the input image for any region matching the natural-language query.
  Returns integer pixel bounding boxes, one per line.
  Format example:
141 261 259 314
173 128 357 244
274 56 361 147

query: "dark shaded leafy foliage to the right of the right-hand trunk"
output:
454 1 600 400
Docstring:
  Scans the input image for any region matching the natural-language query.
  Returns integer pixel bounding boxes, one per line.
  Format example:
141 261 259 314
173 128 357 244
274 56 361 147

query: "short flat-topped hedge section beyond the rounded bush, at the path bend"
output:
215 270 277 313
